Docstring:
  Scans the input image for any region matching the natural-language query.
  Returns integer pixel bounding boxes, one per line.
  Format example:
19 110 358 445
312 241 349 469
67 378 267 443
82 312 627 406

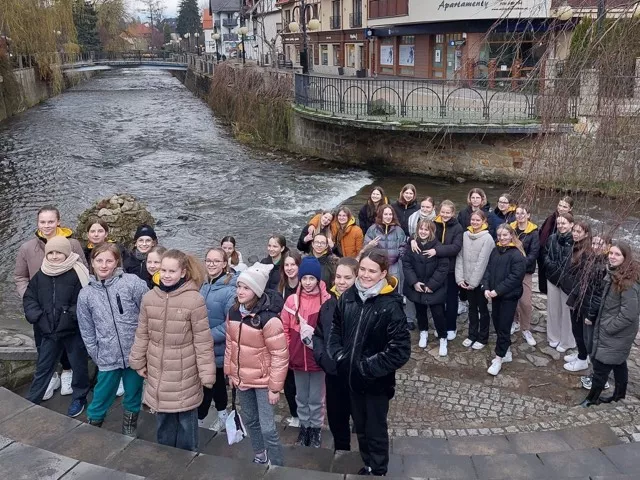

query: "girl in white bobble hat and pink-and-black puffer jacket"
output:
224 263 289 466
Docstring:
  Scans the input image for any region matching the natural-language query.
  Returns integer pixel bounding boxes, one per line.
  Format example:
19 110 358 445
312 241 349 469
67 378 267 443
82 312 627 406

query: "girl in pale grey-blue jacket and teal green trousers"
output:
77 243 149 436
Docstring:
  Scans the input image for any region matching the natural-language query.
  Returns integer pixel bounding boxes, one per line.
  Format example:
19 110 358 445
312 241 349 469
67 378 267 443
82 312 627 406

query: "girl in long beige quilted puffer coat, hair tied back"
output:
129 250 216 451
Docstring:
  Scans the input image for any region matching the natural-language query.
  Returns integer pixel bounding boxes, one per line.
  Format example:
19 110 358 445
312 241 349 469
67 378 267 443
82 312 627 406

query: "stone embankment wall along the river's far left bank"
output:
0 67 99 122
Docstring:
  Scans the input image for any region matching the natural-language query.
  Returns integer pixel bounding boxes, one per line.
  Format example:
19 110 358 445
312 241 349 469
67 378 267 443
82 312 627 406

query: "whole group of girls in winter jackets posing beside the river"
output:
15 184 640 475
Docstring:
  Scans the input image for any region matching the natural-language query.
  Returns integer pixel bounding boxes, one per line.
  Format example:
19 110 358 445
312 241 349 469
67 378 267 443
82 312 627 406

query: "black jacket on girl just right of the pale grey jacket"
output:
482 244 527 300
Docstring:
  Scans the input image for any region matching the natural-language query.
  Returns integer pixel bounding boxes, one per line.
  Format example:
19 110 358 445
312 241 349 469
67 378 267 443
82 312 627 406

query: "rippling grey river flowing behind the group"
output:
0 69 633 331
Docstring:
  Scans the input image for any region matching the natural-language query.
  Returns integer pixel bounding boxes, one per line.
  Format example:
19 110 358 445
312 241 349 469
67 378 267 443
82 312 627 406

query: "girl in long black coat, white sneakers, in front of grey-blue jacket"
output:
402 220 449 357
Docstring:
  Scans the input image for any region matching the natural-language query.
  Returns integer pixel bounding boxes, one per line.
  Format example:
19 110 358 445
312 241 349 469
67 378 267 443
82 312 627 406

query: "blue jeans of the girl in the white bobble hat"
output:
238 388 284 467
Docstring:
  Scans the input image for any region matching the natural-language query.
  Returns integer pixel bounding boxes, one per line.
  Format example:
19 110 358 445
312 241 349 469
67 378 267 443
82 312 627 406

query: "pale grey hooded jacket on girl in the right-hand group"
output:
455 224 496 289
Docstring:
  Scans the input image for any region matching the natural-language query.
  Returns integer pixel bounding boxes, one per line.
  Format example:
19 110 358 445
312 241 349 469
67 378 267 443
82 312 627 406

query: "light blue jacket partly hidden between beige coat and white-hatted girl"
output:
200 273 239 368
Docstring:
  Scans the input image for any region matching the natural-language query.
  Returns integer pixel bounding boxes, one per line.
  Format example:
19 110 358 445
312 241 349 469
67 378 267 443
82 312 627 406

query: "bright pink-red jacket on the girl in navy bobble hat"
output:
280 281 331 372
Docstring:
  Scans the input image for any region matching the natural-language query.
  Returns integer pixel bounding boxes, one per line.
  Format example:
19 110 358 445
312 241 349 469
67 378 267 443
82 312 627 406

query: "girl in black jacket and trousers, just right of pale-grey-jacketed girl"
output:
482 224 527 375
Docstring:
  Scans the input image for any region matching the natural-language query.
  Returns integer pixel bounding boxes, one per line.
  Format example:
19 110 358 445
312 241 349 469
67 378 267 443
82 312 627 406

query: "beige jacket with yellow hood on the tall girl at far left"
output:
14 227 88 297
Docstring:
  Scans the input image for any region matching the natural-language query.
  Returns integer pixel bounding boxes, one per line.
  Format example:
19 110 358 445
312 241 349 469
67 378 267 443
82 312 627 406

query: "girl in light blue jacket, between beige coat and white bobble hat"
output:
198 247 238 432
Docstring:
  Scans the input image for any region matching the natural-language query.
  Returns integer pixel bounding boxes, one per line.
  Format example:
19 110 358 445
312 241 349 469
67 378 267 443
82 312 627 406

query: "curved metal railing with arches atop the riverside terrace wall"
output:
295 74 577 124
